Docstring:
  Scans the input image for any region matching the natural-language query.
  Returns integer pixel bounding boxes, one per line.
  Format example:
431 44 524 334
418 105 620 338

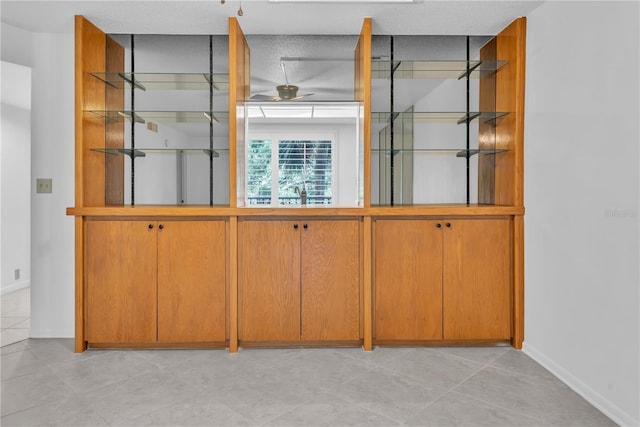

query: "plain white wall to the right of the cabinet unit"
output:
524 1 640 425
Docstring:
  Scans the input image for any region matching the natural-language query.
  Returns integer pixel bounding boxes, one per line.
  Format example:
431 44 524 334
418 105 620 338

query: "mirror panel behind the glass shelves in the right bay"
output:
371 36 502 206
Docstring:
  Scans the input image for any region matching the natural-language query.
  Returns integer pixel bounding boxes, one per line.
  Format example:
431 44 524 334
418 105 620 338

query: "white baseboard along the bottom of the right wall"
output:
522 342 640 427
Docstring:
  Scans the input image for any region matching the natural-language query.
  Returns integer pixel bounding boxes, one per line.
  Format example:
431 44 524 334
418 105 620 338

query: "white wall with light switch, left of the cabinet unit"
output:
1 20 74 337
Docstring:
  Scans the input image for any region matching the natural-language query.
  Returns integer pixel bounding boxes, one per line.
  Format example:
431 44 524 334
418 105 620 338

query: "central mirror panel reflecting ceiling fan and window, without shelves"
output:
237 35 364 207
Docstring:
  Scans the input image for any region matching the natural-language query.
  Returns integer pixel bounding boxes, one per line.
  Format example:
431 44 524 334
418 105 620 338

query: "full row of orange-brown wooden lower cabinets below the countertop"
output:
74 214 524 353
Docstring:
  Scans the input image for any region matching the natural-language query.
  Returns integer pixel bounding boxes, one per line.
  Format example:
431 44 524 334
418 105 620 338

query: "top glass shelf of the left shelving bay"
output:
91 73 229 91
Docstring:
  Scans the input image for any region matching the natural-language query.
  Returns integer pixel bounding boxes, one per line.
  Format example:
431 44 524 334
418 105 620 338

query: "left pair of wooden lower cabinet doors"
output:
85 219 227 346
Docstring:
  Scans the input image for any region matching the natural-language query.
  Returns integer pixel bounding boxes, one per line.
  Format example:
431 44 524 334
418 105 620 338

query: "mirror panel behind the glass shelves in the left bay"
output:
96 34 229 206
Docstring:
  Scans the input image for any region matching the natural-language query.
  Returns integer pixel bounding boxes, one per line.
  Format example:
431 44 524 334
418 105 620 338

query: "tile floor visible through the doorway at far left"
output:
0 287 31 347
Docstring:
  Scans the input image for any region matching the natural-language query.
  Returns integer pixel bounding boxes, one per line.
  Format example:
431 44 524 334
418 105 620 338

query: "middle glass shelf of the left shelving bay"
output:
88 110 229 124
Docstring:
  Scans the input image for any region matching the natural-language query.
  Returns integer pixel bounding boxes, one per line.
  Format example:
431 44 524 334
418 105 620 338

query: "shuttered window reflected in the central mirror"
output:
247 134 335 206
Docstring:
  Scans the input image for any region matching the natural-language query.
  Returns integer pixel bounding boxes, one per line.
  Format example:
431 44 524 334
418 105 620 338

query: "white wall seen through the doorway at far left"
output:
0 61 31 294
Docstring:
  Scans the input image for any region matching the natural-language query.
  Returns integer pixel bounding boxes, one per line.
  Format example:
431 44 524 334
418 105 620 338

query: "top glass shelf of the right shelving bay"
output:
371 60 506 79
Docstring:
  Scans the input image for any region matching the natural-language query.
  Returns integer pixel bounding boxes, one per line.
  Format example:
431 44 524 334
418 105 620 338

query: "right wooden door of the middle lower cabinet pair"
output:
300 220 360 341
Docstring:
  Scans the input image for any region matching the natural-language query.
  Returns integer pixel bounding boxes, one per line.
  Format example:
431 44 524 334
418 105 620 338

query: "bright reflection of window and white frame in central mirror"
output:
244 102 363 207
